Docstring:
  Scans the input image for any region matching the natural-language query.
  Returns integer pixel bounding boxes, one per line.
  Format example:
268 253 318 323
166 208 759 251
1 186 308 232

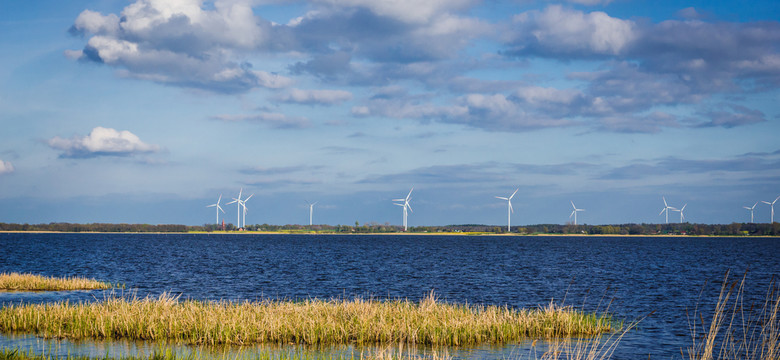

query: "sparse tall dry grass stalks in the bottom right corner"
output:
681 272 780 360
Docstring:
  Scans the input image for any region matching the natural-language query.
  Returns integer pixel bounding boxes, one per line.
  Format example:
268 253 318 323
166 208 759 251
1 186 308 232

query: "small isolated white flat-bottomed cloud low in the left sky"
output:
48 127 160 158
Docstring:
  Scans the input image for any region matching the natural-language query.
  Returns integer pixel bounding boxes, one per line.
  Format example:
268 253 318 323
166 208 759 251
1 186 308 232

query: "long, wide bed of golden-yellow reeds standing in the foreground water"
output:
0 293 616 346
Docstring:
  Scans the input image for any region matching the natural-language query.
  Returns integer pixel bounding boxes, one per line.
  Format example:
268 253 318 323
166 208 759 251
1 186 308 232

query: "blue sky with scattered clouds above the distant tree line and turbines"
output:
0 0 780 226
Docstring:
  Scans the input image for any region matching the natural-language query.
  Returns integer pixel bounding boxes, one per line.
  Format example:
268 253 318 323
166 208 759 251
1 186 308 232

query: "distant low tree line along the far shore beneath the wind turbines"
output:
0 221 780 236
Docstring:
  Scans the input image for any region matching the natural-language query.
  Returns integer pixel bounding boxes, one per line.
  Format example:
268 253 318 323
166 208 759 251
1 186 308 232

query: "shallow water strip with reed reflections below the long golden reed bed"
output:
0 334 617 360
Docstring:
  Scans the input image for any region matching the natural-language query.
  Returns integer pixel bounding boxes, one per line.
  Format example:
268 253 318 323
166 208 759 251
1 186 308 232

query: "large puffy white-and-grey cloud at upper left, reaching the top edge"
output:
65 0 291 93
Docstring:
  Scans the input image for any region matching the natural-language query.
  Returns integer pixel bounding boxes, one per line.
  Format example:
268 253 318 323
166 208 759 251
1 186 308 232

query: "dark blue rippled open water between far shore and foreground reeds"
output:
0 234 780 359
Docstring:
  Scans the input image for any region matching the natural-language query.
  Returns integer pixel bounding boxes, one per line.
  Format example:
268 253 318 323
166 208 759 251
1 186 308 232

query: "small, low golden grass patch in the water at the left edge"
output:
0 273 113 291
